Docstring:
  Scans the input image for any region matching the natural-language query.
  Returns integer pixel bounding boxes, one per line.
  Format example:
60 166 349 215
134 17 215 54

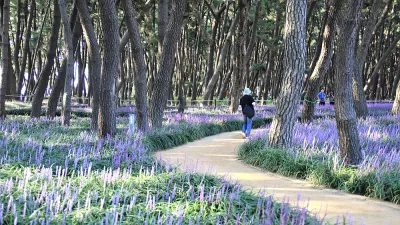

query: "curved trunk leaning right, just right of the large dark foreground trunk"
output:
352 0 384 118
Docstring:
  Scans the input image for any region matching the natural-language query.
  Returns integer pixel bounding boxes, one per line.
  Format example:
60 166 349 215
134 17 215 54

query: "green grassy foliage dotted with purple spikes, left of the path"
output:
0 117 320 224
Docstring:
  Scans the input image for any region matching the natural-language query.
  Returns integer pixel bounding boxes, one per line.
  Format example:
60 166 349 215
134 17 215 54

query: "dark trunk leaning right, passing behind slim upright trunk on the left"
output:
46 4 82 118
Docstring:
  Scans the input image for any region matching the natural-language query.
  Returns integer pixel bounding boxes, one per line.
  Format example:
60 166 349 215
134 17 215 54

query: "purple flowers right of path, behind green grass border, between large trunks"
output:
251 113 400 173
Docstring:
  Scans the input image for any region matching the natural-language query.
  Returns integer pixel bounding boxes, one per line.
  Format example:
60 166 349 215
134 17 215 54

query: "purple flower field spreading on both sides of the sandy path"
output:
0 105 400 224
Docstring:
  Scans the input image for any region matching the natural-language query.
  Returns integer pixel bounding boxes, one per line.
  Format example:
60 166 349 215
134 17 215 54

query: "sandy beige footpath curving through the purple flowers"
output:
155 131 400 225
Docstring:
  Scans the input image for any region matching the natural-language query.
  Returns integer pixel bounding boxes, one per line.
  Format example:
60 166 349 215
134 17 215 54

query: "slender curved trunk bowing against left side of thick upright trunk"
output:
76 1 101 131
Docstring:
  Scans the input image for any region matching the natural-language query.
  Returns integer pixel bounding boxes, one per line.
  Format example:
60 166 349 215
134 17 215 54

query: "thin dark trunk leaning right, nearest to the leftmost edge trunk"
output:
17 0 36 95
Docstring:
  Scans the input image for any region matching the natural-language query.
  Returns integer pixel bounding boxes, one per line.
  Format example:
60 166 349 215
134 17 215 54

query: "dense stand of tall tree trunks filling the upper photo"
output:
0 0 400 161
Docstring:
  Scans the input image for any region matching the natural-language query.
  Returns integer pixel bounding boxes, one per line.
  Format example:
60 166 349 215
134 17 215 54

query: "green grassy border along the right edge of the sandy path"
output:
238 139 400 204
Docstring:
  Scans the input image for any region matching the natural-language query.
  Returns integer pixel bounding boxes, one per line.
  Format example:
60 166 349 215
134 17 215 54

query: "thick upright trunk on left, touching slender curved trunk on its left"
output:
97 0 119 137
